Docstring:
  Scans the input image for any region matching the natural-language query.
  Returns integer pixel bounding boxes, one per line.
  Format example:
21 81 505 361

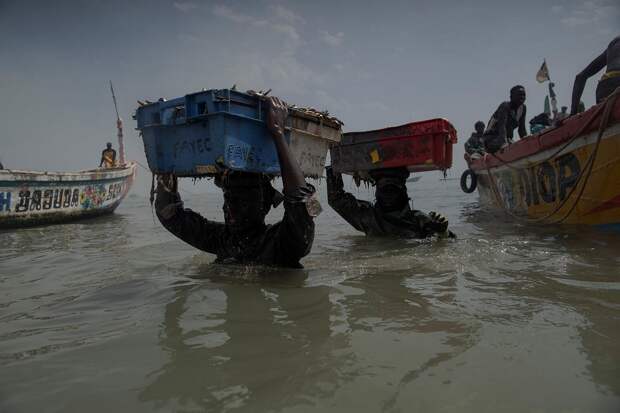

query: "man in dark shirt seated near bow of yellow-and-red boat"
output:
484 85 527 153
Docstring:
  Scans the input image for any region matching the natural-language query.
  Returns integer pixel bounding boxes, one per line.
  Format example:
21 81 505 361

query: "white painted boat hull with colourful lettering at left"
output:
0 163 136 228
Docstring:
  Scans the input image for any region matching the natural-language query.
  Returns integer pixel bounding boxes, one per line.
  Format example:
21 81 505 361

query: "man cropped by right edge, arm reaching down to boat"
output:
570 36 620 115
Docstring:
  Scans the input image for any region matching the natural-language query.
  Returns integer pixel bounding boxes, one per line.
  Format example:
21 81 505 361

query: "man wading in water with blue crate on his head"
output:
155 98 320 268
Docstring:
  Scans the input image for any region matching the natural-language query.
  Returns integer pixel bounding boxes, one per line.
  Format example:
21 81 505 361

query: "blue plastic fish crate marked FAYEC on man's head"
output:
136 89 288 176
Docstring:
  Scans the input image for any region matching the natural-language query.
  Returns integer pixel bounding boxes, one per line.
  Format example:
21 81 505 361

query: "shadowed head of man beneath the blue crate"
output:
215 171 276 231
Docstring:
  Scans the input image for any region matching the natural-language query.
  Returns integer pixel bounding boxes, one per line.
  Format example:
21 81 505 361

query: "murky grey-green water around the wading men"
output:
0 175 620 412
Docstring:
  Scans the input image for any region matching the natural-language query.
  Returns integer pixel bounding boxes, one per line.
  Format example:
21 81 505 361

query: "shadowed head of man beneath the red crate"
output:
370 168 409 212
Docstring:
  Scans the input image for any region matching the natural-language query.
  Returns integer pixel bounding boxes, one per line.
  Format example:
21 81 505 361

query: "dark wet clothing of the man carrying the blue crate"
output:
155 185 315 268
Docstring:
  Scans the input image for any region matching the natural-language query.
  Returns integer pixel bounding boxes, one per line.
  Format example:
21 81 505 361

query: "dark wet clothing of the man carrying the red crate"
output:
327 168 444 238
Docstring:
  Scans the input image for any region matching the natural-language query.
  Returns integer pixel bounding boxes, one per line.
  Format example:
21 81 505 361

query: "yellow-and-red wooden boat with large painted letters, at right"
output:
461 89 620 225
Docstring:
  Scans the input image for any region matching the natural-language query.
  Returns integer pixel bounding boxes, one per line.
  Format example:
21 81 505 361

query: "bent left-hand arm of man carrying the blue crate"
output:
155 175 225 254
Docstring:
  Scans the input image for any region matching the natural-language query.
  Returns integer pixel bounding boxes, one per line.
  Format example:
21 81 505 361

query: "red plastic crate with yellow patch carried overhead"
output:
330 119 456 176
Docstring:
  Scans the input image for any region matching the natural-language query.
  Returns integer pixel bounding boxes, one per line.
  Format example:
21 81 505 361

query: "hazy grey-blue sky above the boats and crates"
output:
0 0 620 175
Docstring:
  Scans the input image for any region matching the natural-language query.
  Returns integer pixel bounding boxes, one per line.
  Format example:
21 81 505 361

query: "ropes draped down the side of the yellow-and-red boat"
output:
485 88 620 224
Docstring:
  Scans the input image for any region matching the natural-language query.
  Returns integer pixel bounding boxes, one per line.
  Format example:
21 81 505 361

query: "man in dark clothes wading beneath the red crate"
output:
326 167 454 238
